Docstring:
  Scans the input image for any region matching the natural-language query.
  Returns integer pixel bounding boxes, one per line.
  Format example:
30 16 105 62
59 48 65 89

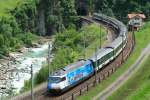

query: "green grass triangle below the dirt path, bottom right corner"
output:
108 56 150 100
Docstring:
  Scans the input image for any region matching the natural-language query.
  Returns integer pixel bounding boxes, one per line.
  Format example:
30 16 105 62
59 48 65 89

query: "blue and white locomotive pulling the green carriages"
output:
47 60 94 93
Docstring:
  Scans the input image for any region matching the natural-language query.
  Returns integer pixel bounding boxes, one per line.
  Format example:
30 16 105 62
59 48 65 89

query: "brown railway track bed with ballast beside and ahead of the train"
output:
11 15 134 100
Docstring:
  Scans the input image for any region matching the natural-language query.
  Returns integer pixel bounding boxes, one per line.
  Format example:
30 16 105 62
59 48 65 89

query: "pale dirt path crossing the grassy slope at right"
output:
93 44 150 100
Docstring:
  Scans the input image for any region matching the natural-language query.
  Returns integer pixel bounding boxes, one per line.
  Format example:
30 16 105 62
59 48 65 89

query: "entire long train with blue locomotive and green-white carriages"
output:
47 13 128 94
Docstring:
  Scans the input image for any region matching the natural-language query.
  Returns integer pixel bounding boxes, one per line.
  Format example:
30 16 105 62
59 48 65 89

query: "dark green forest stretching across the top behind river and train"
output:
0 0 150 57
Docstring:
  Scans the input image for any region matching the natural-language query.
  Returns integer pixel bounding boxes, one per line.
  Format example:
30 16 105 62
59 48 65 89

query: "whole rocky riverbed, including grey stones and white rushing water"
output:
0 39 52 98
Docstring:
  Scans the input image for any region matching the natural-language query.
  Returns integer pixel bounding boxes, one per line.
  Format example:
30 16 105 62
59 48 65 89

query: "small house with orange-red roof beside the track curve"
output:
128 14 146 30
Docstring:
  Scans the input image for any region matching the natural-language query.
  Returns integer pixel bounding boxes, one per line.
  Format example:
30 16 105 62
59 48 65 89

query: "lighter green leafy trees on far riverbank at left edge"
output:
0 17 36 55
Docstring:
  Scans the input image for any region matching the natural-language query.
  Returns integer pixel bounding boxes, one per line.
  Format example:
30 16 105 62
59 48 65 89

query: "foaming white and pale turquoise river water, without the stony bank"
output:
0 43 52 96
